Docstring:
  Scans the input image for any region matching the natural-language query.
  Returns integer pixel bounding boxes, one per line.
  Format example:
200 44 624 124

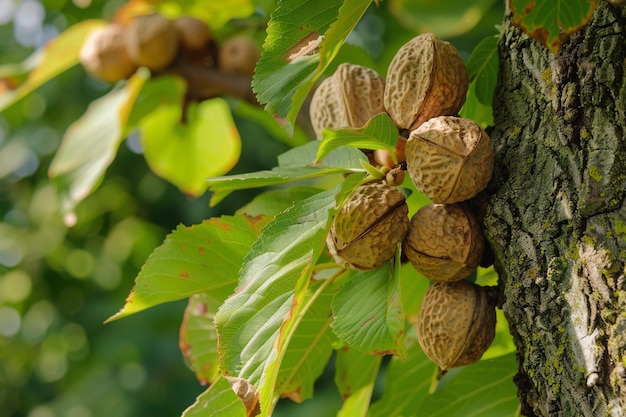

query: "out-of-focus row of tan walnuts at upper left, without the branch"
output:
79 13 260 83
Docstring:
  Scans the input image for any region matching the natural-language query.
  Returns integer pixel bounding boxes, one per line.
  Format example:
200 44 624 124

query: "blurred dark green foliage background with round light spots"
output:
0 0 503 417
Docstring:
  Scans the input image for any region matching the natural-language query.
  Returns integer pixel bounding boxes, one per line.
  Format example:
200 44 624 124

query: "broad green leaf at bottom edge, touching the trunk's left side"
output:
419 354 520 417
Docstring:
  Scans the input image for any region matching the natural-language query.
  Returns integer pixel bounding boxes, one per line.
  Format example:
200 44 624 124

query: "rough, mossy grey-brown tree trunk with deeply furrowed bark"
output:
485 2 626 417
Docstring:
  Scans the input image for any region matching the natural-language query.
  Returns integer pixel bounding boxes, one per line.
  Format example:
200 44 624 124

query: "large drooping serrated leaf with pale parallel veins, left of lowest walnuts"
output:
215 186 339 400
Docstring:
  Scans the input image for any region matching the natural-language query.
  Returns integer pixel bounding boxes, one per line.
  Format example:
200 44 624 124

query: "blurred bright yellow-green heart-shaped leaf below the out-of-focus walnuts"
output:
140 98 241 197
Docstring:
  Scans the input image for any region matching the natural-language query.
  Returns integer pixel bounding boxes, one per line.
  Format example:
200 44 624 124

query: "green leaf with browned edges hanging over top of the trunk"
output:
509 0 600 55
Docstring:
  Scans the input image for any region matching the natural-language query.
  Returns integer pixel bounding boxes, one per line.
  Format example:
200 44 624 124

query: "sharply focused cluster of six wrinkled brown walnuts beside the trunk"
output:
310 33 496 372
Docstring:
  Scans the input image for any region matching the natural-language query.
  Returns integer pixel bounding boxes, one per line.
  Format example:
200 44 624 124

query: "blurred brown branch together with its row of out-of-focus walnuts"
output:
80 13 308 127
